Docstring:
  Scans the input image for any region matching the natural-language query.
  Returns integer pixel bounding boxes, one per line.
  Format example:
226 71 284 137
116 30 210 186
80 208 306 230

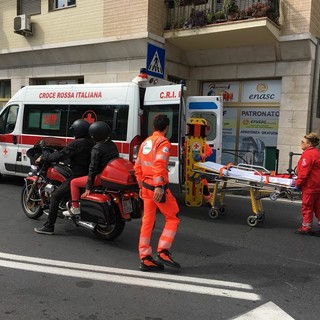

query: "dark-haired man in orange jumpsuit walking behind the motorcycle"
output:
134 114 180 271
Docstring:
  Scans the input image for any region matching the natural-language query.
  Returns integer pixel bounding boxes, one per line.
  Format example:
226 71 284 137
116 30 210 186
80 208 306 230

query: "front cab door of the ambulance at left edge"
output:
0 104 21 175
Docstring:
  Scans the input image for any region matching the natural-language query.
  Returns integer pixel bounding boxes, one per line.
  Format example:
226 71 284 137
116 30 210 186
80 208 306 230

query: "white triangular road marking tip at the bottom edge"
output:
233 301 294 320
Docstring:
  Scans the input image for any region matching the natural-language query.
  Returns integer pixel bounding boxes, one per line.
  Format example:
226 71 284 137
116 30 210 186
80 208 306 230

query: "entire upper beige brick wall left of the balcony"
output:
0 0 159 50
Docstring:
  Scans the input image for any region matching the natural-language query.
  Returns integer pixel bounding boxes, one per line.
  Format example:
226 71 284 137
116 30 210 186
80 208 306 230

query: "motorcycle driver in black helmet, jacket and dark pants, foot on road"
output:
34 119 95 234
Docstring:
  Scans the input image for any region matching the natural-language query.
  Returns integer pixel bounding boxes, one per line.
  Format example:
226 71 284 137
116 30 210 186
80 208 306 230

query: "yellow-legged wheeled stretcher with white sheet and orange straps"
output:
191 161 299 227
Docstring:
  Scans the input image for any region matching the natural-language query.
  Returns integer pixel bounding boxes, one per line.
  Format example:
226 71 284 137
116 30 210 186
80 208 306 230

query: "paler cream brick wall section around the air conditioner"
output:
0 0 103 49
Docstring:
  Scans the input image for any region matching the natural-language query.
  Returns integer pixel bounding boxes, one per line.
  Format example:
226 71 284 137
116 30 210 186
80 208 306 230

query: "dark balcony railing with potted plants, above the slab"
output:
165 0 280 30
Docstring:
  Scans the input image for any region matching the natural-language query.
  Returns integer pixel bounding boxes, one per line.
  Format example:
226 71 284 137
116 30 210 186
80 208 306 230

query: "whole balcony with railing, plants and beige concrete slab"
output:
164 0 280 50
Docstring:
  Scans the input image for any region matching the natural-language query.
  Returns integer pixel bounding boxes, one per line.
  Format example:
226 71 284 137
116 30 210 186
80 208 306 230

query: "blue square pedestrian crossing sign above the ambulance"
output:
147 43 165 79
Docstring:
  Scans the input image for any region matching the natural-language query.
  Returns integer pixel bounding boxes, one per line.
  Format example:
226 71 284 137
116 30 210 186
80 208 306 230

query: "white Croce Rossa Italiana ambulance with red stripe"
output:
0 70 221 183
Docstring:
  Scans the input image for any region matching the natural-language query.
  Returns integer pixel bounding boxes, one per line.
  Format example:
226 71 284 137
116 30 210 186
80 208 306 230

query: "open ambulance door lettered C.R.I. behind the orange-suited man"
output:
141 84 186 184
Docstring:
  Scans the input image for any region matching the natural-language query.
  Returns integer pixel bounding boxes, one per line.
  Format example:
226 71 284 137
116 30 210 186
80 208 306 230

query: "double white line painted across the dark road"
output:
0 252 261 301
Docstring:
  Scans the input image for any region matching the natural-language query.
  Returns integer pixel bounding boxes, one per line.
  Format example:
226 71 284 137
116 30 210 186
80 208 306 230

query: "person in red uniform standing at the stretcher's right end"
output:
296 132 320 235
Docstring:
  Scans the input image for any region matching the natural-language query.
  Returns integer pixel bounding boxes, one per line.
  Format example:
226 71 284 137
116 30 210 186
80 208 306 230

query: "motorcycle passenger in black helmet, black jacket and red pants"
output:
63 121 119 217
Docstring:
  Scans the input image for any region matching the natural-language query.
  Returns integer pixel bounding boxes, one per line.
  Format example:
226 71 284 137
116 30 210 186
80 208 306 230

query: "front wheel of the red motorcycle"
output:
21 183 43 219
